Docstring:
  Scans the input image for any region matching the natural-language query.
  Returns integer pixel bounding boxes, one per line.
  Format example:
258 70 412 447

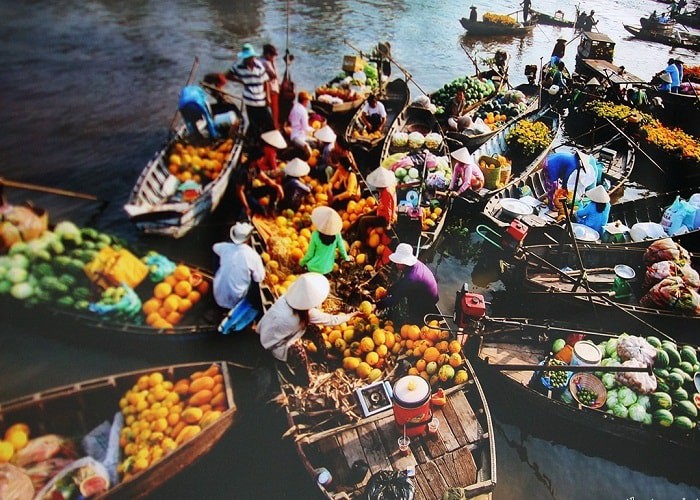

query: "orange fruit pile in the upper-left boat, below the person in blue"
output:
168 139 233 184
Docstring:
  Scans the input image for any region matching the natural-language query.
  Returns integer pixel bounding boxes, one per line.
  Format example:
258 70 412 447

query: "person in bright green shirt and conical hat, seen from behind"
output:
299 207 352 274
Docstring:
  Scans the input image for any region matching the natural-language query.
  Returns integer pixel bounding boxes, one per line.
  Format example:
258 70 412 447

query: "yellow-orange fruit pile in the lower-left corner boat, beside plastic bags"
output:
118 365 227 479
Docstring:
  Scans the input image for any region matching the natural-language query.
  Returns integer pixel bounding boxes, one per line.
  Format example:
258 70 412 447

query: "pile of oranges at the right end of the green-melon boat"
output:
142 264 209 330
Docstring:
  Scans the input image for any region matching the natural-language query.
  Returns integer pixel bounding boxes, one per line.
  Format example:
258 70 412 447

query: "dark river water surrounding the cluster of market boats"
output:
0 0 700 499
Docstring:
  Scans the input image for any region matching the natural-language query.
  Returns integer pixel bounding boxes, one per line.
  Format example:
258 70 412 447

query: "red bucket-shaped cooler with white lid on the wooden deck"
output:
393 375 433 436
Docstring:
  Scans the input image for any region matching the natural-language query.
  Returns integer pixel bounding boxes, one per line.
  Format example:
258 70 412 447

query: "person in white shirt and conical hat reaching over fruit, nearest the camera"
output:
256 273 358 383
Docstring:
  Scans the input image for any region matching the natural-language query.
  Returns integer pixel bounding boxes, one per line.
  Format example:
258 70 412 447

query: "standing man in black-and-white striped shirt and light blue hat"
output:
224 43 274 140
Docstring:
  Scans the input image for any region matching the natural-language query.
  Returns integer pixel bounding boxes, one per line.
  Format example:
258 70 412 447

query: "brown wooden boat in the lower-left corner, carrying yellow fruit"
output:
0 362 236 498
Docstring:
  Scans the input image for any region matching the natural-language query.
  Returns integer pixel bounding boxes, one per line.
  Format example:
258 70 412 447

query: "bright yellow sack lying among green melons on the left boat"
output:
84 246 148 288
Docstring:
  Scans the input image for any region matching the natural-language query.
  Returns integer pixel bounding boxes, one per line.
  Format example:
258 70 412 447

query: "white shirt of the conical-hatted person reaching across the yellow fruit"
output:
256 295 352 361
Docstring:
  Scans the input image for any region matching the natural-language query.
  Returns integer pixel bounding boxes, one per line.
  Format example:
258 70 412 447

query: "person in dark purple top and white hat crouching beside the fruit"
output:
377 243 440 324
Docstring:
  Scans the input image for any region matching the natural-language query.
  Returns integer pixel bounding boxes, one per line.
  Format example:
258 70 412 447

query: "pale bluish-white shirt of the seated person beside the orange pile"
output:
212 243 265 309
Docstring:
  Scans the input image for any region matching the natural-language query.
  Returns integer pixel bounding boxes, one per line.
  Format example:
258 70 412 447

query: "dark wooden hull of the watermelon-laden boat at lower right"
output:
465 318 700 484
